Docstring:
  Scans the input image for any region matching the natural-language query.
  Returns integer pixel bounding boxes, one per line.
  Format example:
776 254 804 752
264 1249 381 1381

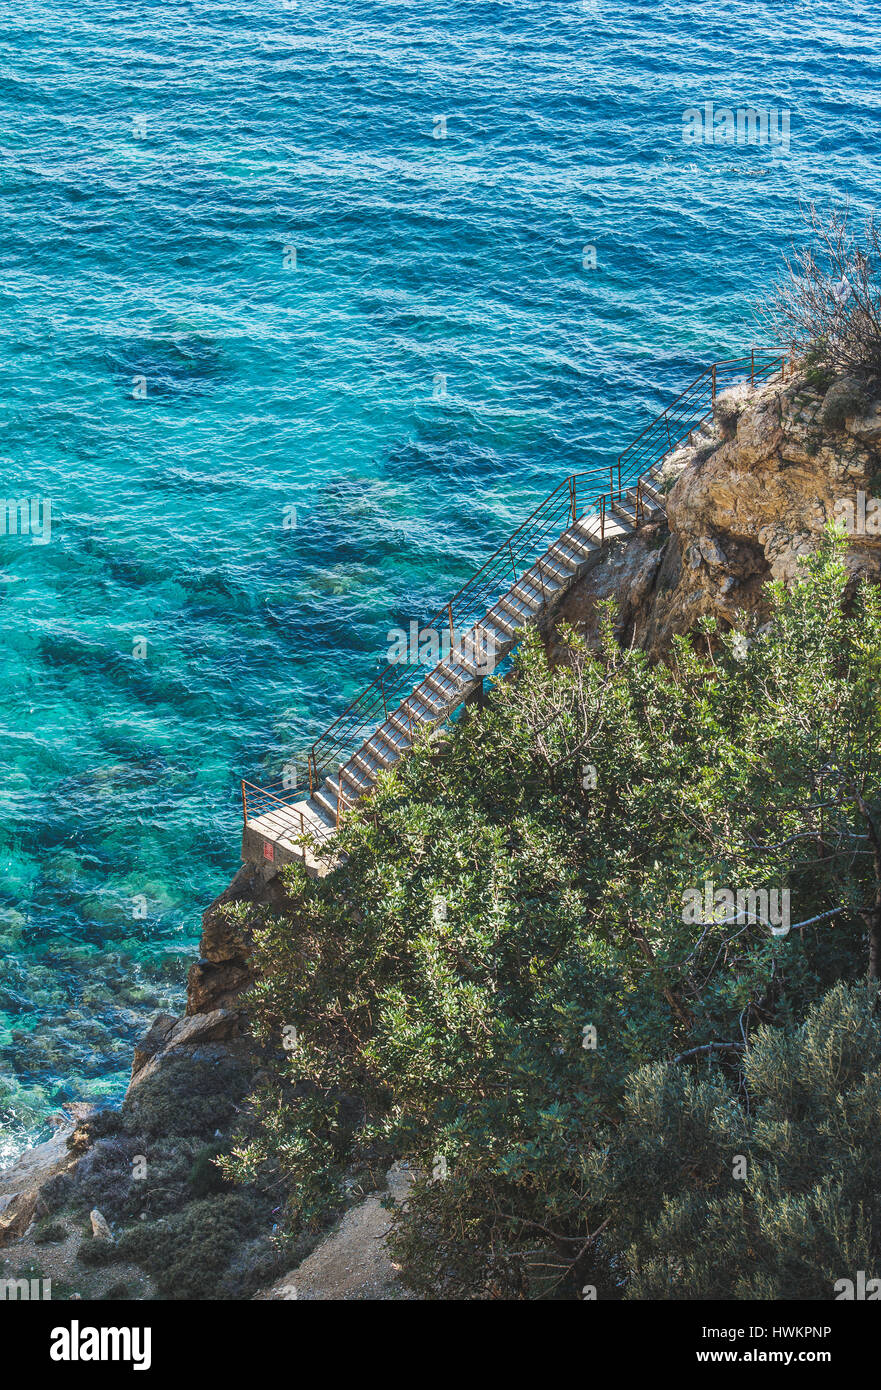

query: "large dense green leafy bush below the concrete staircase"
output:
220 539 881 1298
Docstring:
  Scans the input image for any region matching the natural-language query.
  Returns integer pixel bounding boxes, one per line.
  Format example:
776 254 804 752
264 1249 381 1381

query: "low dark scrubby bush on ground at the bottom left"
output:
42 1058 286 1300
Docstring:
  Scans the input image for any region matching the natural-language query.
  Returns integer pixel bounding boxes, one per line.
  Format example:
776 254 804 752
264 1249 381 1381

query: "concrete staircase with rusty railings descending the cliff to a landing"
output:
242 349 787 874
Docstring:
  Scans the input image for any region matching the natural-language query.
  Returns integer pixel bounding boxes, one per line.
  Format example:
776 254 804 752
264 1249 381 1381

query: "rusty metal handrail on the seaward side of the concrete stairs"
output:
242 349 785 834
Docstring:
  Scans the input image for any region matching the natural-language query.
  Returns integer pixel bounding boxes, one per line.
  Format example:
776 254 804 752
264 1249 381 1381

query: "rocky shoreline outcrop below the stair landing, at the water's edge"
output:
0 866 283 1297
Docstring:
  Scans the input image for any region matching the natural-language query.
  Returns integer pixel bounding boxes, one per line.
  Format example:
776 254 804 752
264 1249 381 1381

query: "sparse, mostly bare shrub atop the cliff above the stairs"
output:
759 203 881 377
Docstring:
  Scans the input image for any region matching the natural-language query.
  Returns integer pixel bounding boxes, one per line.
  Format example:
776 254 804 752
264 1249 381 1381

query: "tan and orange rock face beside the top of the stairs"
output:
547 364 881 656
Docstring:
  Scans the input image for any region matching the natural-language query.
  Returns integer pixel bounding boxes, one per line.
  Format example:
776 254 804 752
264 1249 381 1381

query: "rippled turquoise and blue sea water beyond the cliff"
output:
0 0 881 1156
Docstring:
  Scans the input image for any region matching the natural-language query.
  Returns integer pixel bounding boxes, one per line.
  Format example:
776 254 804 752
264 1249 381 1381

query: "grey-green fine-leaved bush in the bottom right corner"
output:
589 981 881 1300
